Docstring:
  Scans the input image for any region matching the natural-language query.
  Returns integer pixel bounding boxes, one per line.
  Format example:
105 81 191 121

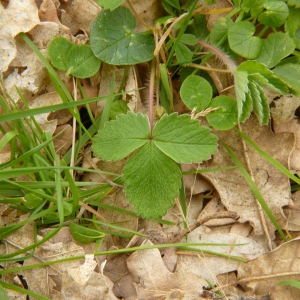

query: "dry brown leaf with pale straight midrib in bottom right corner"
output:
238 239 300 299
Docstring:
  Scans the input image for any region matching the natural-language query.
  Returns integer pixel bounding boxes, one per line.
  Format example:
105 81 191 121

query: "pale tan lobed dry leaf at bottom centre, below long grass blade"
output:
127 241 207 300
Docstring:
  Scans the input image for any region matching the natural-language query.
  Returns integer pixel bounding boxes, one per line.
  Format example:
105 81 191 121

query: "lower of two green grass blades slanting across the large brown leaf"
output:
220 140 287 242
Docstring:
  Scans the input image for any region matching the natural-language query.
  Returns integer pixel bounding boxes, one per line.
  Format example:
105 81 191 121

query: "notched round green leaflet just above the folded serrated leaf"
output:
228 21 262 59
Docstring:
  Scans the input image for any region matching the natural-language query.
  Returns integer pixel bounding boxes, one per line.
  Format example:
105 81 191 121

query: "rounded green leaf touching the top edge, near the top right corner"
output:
258 1 289 27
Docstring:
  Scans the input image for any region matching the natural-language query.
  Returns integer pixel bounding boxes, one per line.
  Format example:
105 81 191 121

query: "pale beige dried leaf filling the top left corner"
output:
0 0 40 73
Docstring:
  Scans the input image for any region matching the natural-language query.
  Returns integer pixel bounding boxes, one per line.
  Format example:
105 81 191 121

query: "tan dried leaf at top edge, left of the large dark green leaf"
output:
60 0 101 35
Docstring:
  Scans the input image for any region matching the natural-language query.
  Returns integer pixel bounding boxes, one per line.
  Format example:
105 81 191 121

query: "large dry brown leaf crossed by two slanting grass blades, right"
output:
200 117 294 236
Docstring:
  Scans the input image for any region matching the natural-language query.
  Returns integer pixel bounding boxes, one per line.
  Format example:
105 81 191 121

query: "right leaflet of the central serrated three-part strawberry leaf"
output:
152 113 217 163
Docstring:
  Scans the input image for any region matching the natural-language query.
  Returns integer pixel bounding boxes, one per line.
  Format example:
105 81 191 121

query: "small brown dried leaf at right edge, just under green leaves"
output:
271 94 300 125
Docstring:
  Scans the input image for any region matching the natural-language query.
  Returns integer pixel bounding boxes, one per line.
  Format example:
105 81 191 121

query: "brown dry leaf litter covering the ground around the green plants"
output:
0 0 300 299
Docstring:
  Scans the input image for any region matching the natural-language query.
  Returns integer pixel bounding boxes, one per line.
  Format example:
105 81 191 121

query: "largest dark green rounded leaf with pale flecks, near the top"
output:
90 6 155 65
